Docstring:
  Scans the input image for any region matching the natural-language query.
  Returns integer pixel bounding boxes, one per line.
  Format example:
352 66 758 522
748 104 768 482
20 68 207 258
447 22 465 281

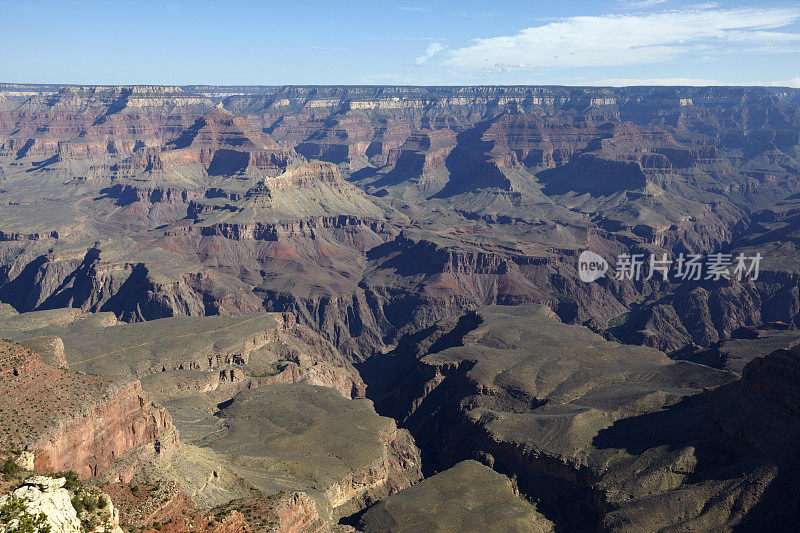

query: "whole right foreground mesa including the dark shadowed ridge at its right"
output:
364 306 800 531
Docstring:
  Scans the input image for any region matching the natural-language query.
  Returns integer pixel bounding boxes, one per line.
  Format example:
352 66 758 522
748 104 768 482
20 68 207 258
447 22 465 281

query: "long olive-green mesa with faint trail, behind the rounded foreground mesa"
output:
0 310 364 401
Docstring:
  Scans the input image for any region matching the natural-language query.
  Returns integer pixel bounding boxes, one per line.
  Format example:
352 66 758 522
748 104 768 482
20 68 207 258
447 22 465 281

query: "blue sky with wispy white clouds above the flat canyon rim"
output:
0 0 800 87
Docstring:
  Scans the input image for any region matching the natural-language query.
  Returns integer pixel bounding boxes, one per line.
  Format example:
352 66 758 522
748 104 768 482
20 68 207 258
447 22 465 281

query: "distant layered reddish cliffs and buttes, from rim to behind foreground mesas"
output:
0 85 800 359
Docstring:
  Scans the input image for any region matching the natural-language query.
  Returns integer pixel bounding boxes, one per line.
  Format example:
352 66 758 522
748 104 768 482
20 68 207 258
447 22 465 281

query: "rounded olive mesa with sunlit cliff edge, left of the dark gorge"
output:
203 383 421 519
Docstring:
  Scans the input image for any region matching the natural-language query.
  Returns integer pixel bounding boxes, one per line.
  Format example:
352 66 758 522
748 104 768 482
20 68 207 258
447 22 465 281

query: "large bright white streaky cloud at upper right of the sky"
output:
444 5 800 72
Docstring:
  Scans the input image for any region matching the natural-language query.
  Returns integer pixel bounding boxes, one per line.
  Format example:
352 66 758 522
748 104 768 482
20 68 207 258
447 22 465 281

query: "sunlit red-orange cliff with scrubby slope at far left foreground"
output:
0 341 178 478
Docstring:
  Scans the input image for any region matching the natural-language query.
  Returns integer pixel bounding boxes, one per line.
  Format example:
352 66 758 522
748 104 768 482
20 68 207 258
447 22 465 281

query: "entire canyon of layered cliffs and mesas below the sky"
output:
0 83 800 532
